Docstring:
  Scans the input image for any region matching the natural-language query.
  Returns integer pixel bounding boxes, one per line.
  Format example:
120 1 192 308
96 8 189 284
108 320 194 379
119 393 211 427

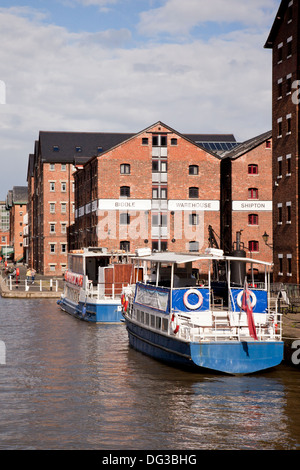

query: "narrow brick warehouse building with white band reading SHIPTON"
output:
221 131 273 268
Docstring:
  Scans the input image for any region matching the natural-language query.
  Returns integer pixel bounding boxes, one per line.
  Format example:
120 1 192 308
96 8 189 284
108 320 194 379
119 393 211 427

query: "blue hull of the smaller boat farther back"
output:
57 297 124 324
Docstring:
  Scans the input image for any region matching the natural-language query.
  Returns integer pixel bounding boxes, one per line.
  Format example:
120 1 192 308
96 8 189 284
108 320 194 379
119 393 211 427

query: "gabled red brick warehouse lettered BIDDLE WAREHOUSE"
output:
73 122 234 258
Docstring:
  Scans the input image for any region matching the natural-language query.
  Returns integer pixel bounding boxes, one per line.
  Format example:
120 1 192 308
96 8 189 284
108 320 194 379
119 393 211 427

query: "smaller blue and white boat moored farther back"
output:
57 247 134 323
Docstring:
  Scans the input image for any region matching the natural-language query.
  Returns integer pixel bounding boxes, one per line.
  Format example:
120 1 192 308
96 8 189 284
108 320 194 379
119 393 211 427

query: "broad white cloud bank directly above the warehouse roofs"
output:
0 2 271 198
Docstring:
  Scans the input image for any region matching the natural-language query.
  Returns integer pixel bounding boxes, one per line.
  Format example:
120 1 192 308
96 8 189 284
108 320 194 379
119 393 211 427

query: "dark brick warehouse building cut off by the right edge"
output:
265 0 300 284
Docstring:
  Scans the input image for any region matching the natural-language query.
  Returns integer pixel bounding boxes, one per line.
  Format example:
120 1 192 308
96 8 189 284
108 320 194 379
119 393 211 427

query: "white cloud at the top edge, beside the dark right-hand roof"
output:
139 0 278 36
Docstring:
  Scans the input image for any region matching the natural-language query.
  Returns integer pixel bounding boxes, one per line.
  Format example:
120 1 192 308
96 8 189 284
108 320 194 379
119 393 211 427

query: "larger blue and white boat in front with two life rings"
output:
123 249 283 375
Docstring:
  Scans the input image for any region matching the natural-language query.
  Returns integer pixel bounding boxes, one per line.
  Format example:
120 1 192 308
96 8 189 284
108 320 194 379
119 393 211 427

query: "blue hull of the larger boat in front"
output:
125 317 283 375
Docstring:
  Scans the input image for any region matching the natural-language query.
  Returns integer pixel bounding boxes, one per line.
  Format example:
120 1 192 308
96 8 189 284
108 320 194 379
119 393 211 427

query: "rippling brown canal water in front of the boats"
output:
0 298 300 451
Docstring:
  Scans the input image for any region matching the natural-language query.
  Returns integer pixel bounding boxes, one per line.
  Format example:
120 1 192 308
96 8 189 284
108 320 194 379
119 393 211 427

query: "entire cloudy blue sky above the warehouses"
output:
0 0 280 200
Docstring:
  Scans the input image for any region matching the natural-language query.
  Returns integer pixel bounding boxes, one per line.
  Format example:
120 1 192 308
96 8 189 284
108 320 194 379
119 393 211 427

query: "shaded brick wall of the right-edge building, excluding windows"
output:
272 1 300 283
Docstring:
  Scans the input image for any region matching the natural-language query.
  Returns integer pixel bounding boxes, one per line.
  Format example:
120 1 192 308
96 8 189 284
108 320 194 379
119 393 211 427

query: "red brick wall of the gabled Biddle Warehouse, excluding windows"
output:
75 124 220 255
